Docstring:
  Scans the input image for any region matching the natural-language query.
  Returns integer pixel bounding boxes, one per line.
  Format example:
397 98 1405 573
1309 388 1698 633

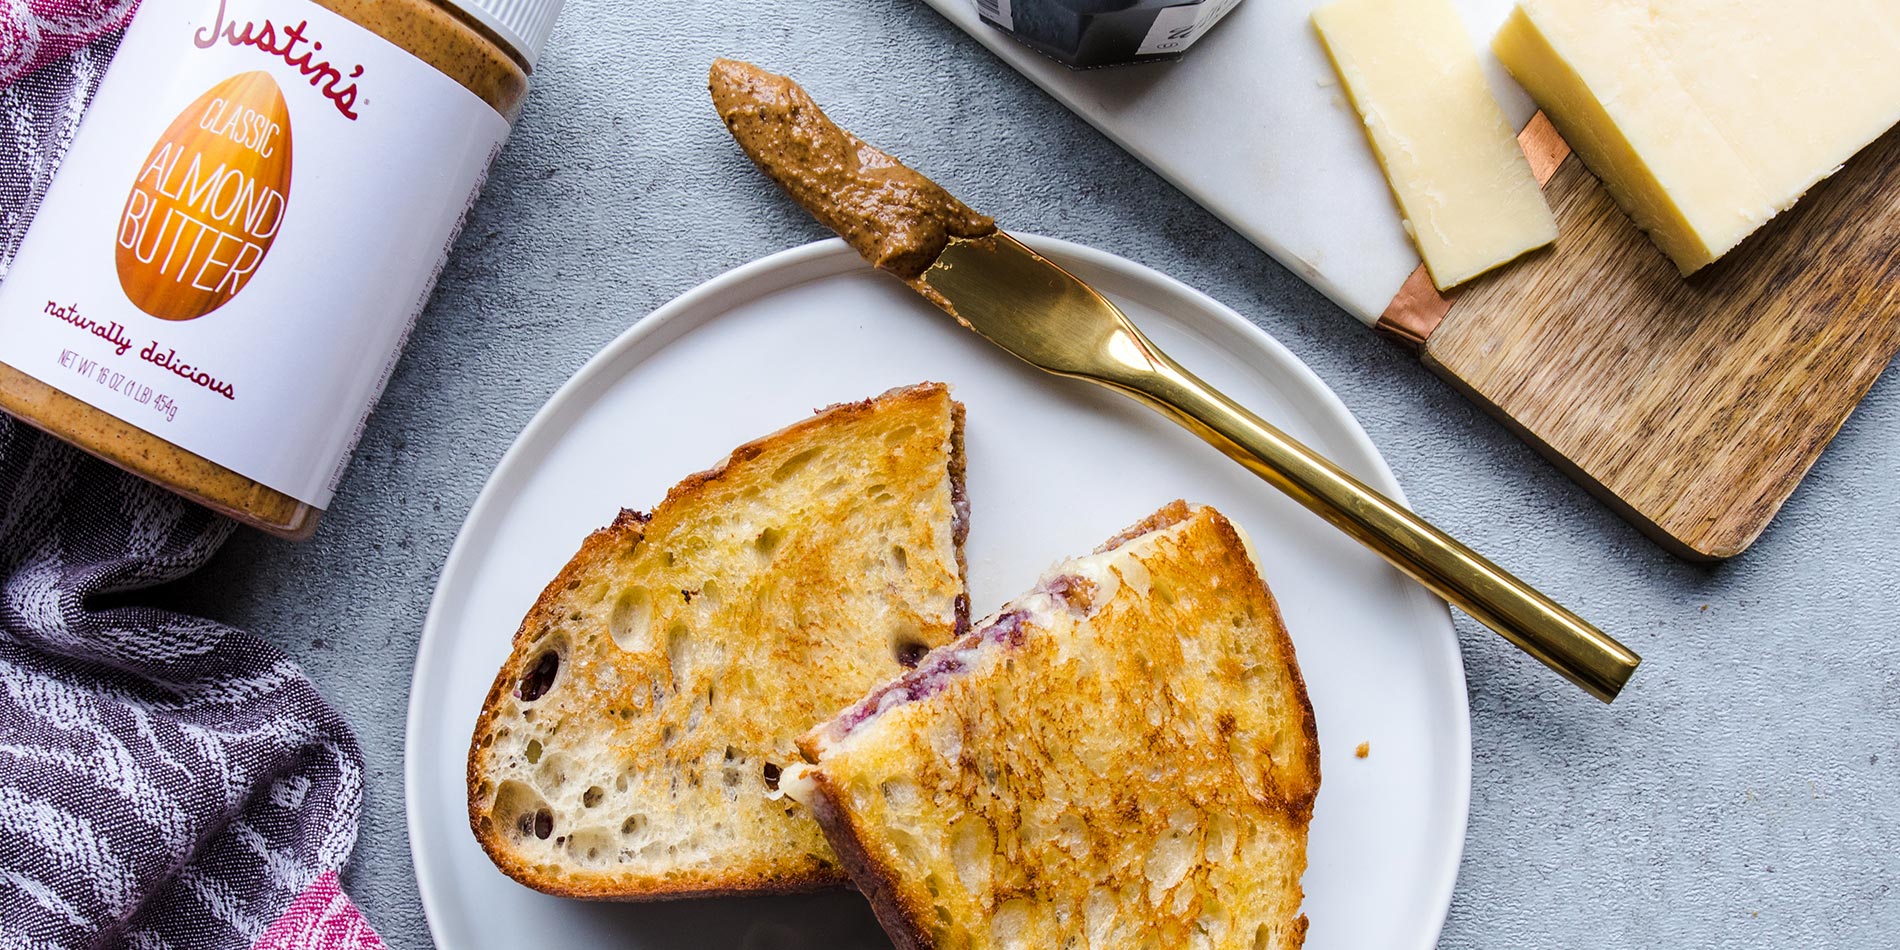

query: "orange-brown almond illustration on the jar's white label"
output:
116 70 291 319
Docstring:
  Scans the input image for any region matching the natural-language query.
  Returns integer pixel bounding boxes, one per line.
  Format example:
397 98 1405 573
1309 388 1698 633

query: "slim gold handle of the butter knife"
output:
1096 342 1642 703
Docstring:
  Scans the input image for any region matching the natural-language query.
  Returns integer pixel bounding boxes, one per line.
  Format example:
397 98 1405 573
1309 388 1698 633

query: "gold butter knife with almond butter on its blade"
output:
709 59 1642 703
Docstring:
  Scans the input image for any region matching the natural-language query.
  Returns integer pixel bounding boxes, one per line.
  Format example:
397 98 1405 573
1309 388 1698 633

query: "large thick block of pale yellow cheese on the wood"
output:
1492 0 1900 274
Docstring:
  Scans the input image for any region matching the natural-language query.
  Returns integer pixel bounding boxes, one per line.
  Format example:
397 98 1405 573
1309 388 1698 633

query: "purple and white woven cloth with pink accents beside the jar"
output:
0 0 382 950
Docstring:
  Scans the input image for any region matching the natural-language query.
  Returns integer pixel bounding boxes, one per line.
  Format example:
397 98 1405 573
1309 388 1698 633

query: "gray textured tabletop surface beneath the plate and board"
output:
155 0 1900 948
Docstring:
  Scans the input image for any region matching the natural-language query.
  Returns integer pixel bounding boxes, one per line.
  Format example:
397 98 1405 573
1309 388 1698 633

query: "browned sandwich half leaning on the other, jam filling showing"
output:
787 502 1319 950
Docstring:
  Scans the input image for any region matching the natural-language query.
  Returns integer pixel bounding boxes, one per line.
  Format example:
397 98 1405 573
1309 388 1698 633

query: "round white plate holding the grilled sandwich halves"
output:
407 239 1471 950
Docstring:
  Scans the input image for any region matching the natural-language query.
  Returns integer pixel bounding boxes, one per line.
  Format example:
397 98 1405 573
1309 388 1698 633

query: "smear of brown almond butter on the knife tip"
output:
707 59 996 281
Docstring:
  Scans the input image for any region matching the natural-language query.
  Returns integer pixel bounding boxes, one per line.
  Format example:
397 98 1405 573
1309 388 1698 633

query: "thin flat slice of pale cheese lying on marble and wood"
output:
1313 0 1556 291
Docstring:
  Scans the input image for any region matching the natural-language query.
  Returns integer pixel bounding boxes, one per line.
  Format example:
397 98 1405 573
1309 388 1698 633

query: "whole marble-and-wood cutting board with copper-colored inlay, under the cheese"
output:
927 0 1900 559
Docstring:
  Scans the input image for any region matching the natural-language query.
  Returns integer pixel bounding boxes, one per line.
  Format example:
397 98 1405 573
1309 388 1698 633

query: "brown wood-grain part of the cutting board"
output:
1423 129 1900 559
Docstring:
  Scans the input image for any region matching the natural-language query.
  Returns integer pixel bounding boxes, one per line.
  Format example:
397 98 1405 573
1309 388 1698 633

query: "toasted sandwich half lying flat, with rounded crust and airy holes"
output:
467 384 967 899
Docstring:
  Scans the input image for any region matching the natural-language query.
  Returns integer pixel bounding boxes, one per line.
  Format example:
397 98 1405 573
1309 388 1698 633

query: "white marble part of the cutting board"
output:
925 0 1535 325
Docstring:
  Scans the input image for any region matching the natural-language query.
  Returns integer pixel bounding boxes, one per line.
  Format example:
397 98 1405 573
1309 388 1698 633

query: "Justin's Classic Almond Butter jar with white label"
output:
0 0 561 538
